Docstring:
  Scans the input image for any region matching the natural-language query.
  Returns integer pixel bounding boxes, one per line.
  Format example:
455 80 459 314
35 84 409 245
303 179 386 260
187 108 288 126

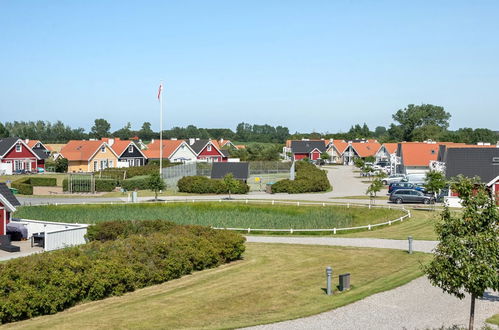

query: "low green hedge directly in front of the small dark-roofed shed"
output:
177 176 249 194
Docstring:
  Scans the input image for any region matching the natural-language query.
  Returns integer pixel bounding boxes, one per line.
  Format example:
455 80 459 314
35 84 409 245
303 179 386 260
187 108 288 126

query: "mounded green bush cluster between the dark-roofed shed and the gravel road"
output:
272 161 331 194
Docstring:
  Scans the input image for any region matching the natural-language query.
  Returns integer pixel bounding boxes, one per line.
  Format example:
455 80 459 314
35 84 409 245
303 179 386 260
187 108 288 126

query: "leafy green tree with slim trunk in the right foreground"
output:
423 176 499 329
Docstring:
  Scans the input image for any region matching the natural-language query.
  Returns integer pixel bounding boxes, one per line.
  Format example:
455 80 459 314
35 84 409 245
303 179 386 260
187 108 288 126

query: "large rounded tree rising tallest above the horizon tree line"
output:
388 104 451 141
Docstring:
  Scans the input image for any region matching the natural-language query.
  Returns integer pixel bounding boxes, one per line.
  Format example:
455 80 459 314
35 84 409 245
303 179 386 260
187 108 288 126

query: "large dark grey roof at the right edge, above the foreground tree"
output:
445 148 499 183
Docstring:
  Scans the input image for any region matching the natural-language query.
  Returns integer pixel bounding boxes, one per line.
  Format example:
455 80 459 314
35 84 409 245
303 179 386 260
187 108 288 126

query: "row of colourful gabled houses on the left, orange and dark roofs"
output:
0 137 244 174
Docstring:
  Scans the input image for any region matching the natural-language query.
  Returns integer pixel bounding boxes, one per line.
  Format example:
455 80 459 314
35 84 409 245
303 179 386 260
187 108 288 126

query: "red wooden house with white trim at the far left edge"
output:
0 137 41 173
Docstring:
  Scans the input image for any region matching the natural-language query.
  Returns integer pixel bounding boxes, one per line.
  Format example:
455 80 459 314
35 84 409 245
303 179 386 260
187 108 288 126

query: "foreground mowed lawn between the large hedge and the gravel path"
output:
5 243 430 329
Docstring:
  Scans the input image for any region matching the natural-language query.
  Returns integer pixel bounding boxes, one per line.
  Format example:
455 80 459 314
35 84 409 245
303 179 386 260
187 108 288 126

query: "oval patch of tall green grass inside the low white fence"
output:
16 202 404 229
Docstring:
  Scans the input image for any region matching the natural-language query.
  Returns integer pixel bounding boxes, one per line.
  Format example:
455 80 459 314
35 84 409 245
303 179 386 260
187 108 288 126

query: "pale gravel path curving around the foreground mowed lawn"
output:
247 236 499 330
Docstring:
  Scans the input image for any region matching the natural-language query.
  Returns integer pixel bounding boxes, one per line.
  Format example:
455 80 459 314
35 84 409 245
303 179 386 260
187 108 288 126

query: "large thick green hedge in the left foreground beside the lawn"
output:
0 221 244 323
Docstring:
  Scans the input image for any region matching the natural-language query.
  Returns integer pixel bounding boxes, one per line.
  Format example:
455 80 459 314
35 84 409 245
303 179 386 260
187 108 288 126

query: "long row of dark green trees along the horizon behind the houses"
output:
0 104 499 144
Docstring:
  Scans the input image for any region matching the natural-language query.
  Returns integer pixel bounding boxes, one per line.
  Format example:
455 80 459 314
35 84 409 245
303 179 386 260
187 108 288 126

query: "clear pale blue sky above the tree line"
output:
0 0 499 132
